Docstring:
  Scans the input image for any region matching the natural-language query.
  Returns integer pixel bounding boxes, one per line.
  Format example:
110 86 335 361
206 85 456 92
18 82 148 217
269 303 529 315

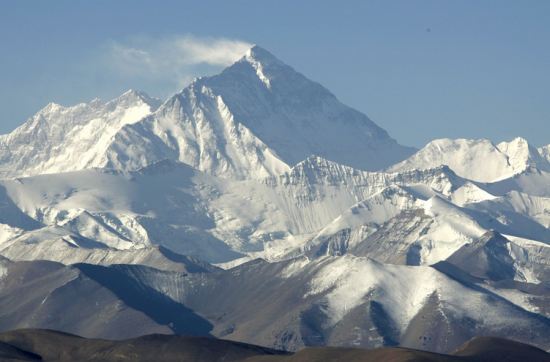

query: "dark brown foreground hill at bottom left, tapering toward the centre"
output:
0 329 286 362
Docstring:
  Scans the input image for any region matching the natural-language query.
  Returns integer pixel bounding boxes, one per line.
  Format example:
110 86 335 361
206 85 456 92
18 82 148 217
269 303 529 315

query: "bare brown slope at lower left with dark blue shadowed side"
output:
0 261 211 339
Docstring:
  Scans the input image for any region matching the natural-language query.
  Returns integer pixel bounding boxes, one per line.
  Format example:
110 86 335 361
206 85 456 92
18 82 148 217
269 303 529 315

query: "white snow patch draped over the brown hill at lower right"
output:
306 256 540 333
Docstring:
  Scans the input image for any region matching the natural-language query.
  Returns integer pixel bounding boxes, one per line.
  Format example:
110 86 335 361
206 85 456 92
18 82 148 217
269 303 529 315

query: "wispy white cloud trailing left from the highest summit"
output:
104 34 252 85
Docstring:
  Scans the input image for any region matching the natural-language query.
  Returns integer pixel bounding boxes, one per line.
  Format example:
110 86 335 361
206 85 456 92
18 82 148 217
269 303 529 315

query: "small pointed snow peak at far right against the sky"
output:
497 137 550 173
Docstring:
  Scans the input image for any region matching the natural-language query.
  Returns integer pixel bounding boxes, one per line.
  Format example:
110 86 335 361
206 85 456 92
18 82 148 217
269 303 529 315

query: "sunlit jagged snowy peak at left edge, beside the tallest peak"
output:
0 90 160 178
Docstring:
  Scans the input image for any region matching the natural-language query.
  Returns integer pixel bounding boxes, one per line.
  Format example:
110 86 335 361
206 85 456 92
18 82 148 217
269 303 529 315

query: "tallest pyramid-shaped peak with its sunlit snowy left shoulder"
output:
101 46 414 180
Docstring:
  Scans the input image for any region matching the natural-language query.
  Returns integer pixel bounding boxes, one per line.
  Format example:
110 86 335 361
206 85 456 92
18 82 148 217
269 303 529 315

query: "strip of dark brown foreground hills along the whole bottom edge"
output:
0 329 550 362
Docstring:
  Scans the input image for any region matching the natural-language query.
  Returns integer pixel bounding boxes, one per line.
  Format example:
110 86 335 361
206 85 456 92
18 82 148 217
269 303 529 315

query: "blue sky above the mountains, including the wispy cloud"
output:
0 0 550 147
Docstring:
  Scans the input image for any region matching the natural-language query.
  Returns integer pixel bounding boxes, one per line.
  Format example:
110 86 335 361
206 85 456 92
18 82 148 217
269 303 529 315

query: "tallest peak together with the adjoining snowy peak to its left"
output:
0 46 414 179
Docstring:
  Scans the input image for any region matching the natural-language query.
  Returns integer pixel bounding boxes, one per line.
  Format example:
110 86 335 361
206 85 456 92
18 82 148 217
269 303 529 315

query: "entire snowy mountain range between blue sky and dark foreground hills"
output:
0 46 550 353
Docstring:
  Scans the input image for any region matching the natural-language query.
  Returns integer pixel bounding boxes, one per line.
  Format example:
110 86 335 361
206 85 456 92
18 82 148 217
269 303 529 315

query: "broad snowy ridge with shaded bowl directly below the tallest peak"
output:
2 158 463 262
